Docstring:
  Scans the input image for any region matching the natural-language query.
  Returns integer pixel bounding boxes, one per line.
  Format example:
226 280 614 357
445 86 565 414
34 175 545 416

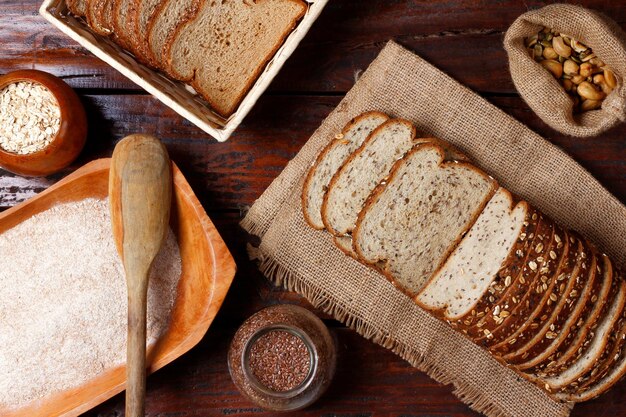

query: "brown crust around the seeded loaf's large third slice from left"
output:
354 143 498 298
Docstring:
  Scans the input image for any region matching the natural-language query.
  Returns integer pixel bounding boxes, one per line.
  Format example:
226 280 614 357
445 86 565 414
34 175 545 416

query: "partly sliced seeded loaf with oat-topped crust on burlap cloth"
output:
302 112 626 402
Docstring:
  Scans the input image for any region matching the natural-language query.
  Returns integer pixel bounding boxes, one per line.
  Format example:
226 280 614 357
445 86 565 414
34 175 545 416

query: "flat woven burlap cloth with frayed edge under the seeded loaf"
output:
242 42 626 417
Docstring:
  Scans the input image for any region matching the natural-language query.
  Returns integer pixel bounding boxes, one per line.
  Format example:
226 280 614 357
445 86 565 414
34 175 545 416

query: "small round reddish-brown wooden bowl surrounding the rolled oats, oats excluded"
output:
0 70 87 177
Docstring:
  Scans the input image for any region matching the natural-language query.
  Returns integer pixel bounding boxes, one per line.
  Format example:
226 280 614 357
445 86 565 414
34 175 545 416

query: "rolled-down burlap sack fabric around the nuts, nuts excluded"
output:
504 4 626 137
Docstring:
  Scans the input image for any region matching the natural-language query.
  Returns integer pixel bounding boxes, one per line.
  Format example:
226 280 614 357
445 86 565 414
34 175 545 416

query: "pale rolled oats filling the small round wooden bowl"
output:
0 81 61 155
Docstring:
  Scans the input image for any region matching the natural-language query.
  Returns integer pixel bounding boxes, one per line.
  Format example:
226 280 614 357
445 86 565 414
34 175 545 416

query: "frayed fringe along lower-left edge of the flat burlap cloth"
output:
242 244 574 417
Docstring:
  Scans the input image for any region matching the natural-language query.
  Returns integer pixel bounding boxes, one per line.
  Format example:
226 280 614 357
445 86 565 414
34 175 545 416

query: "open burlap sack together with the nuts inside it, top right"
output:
504 4 626 137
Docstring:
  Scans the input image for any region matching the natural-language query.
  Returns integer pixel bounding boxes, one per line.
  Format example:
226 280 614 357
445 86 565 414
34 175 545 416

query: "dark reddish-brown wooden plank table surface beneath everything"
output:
0 0 626 417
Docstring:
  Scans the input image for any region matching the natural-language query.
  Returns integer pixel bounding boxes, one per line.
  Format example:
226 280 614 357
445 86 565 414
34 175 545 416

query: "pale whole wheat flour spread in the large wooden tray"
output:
0 199 181 409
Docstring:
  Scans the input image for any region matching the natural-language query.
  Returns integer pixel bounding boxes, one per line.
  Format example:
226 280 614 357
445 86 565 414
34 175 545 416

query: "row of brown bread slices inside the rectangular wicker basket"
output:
67 0 307 117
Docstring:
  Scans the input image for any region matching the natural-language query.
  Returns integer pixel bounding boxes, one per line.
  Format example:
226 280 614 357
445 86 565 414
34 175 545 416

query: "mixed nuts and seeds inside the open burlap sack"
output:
525 28 617 113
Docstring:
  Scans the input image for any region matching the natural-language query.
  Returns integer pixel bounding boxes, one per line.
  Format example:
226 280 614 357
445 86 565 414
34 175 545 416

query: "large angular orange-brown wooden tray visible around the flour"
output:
0 159 236 417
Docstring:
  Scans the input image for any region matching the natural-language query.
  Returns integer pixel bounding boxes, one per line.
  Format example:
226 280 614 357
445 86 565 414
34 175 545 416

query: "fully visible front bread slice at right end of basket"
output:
164 0 307 117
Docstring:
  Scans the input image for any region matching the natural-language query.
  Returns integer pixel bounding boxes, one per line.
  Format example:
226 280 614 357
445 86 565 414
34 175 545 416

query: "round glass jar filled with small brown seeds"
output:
228 305 337 411
